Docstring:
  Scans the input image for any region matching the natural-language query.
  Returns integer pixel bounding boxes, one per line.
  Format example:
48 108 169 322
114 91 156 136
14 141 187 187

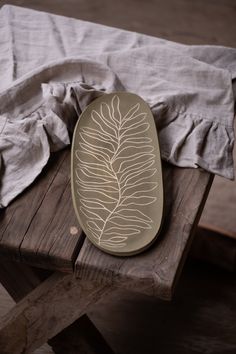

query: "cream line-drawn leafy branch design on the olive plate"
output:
75 95 158 249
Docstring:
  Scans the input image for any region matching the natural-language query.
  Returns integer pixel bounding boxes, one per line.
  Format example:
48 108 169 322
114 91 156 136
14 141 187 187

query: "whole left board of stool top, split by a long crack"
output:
0 150 83 272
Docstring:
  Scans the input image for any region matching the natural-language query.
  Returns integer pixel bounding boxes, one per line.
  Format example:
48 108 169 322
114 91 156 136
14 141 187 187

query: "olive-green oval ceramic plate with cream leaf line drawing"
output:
72 92 163 256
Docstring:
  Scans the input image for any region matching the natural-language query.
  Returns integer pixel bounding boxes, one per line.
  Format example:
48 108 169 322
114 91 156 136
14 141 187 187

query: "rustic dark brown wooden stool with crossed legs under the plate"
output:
0 149 213 354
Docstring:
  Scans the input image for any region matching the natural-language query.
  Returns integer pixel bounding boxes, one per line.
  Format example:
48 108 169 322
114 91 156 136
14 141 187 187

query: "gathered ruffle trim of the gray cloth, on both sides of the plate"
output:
0 82 234 207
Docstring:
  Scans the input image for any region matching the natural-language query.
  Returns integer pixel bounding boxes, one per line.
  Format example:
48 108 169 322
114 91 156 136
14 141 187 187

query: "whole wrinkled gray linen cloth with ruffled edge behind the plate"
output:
0 6 236 208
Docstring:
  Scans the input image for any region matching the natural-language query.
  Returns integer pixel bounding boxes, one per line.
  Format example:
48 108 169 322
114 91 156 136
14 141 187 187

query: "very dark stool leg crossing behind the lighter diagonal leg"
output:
0 261 113 354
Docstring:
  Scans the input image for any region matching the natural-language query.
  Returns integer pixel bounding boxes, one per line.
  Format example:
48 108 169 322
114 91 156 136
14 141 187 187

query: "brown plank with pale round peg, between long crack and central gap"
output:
20 151 83 271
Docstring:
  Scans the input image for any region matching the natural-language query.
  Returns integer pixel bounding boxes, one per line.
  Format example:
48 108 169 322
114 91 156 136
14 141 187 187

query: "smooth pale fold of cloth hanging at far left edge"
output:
0 112 50 208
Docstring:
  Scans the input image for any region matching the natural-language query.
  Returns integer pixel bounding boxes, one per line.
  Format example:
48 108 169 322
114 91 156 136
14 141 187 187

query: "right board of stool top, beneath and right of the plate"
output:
76 164 213 300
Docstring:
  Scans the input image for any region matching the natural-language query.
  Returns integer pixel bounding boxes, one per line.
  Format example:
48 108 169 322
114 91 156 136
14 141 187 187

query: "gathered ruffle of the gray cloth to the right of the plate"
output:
151 104 234 180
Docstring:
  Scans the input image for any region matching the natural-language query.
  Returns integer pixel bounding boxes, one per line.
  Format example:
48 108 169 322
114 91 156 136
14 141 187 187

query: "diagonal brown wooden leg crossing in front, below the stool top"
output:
0 273 116 354
